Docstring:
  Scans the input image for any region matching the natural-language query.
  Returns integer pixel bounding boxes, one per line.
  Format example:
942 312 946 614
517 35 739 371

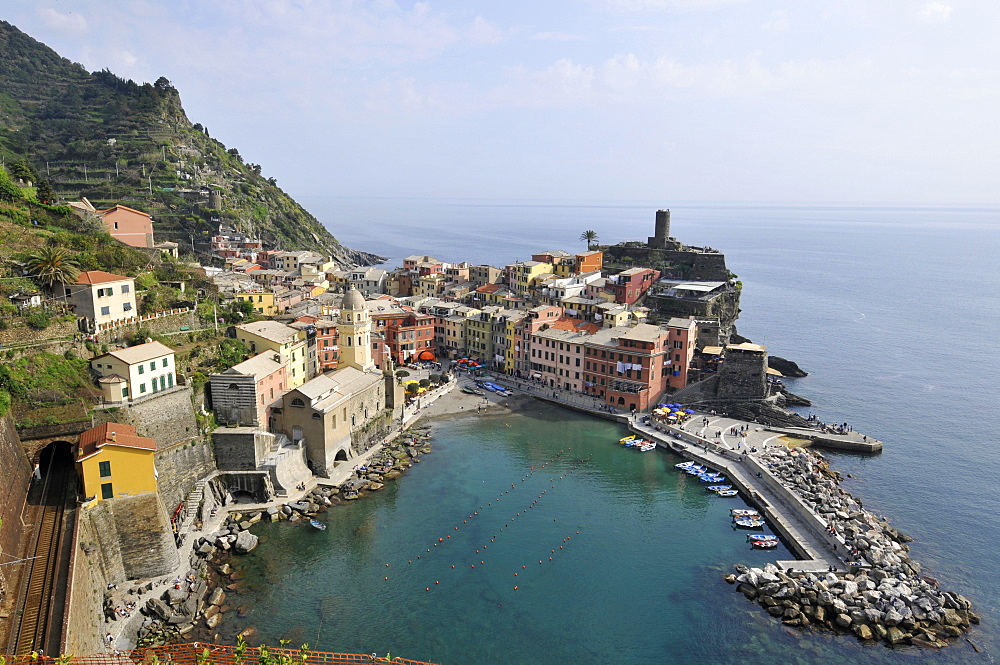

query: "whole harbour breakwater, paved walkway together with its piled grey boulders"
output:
630 423 980 648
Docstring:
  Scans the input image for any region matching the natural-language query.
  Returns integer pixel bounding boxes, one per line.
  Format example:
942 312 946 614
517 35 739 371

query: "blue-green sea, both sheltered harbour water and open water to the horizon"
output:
223 197 1000 665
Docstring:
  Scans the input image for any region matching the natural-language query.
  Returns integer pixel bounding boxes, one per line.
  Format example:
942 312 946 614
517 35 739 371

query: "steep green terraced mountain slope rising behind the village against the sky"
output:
0 21 379 266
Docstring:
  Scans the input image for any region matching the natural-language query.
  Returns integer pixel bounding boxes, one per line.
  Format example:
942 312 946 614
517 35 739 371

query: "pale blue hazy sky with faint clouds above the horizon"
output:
0 0 1000 204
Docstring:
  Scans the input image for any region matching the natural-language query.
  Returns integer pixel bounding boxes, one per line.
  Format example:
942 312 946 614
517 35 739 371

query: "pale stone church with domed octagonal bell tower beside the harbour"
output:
277 288 404 477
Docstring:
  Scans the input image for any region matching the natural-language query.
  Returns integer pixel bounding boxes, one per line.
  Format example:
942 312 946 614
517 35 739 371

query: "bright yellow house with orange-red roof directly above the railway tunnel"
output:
76 423 156 501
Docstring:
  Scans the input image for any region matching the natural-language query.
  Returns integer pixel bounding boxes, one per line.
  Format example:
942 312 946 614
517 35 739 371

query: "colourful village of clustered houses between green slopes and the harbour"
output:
0 162 768 648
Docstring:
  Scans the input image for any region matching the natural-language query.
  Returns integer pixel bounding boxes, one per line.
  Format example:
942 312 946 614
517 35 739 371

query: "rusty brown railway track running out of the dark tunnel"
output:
9 450 76 655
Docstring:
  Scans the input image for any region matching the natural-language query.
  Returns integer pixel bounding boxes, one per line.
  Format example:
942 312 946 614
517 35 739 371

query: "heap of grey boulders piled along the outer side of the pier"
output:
726 448 979 647
